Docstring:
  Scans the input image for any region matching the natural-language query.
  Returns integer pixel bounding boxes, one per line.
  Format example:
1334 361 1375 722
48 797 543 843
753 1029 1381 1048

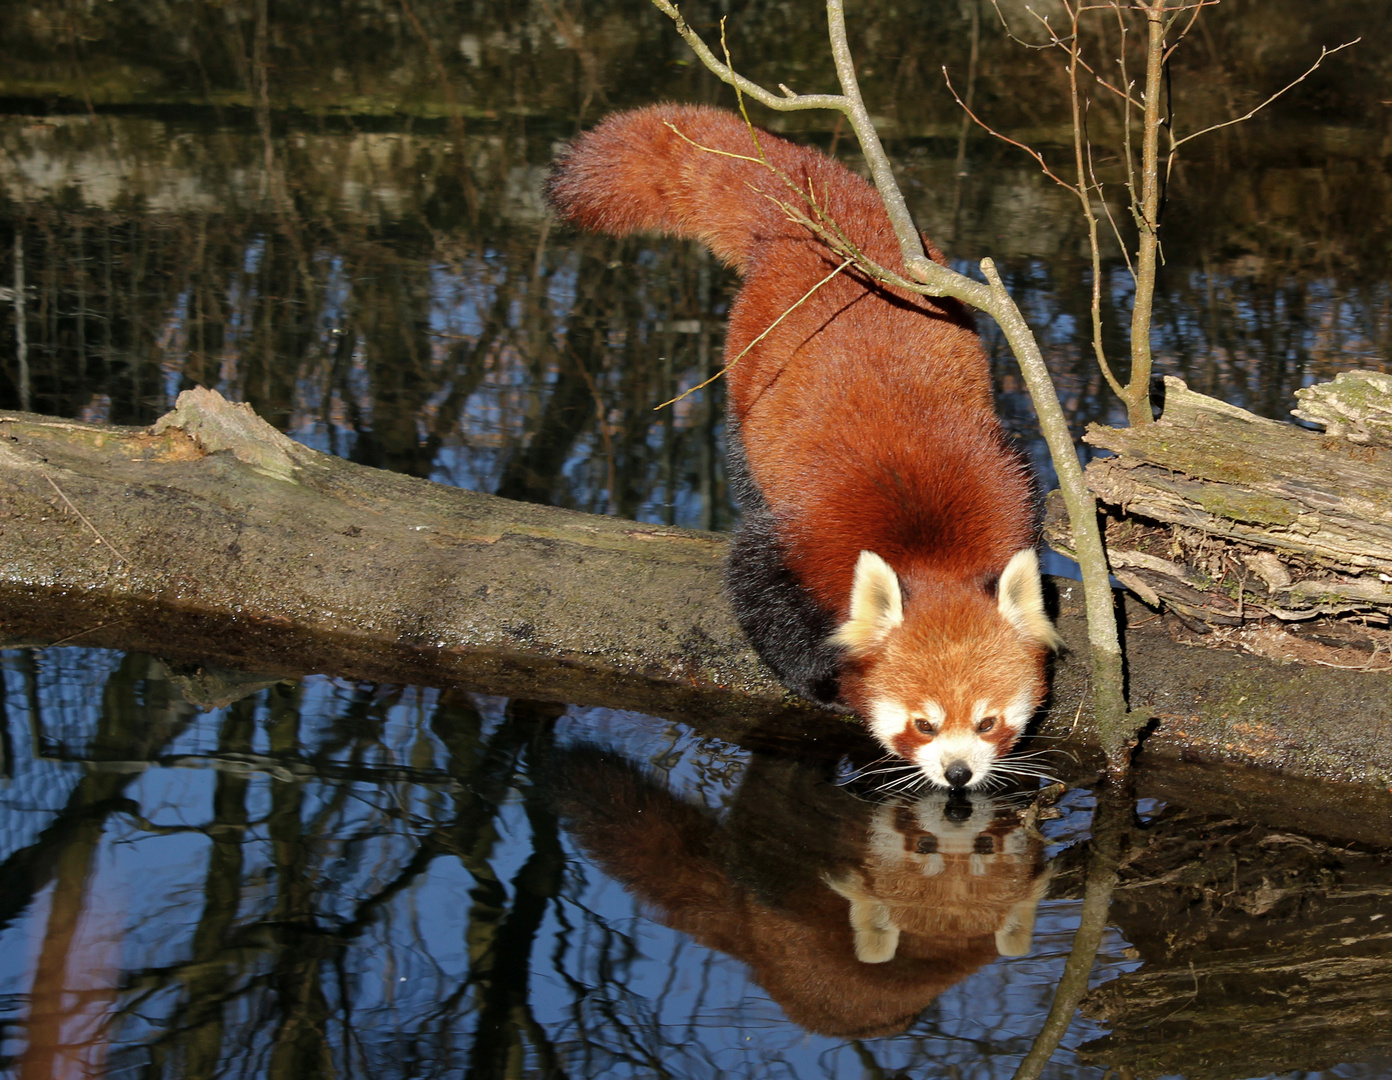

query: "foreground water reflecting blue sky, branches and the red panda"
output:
0 649 1133 1080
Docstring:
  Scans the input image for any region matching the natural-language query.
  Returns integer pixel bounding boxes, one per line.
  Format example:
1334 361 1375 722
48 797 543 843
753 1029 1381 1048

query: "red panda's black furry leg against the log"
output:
725 418 849 713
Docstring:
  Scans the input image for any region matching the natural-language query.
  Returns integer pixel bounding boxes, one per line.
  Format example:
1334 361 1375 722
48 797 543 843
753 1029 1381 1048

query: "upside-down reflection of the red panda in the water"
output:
540 746 1048 1038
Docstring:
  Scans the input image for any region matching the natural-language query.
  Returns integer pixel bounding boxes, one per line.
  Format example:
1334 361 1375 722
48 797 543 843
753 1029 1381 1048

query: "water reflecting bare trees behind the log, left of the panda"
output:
0 149 728 525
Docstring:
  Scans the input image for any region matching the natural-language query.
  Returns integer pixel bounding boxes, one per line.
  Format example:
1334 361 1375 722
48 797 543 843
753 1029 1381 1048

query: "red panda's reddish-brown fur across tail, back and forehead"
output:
550 98 1044 752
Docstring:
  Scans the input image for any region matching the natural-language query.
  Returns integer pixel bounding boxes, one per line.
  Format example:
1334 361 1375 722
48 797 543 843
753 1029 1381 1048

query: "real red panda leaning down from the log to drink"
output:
548 106 1057 788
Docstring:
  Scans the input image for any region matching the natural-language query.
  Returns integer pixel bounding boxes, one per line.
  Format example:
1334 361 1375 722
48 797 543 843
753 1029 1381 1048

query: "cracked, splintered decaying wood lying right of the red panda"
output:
1045 373 1392 637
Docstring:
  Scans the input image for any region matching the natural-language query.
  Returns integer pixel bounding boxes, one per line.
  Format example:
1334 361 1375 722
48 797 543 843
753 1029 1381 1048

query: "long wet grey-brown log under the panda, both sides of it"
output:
0 395 1392 843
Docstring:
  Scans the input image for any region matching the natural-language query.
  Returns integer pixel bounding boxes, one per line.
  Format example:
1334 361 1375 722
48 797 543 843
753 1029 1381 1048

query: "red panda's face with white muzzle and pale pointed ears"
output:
832 551 1057 788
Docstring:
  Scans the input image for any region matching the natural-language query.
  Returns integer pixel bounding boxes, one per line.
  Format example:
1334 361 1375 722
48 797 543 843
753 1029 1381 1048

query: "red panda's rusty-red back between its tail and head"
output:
729 245 1033 611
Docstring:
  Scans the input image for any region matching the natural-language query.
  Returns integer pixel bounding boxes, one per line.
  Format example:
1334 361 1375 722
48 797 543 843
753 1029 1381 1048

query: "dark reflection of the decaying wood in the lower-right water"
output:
1079 807 1392 1080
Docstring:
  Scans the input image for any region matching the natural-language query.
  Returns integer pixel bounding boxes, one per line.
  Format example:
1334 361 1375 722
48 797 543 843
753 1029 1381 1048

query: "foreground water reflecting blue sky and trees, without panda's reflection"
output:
0 650 1136 1077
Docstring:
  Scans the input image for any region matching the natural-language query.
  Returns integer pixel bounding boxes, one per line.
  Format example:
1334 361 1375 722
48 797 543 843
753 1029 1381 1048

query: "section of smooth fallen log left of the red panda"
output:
0 390 810 734
